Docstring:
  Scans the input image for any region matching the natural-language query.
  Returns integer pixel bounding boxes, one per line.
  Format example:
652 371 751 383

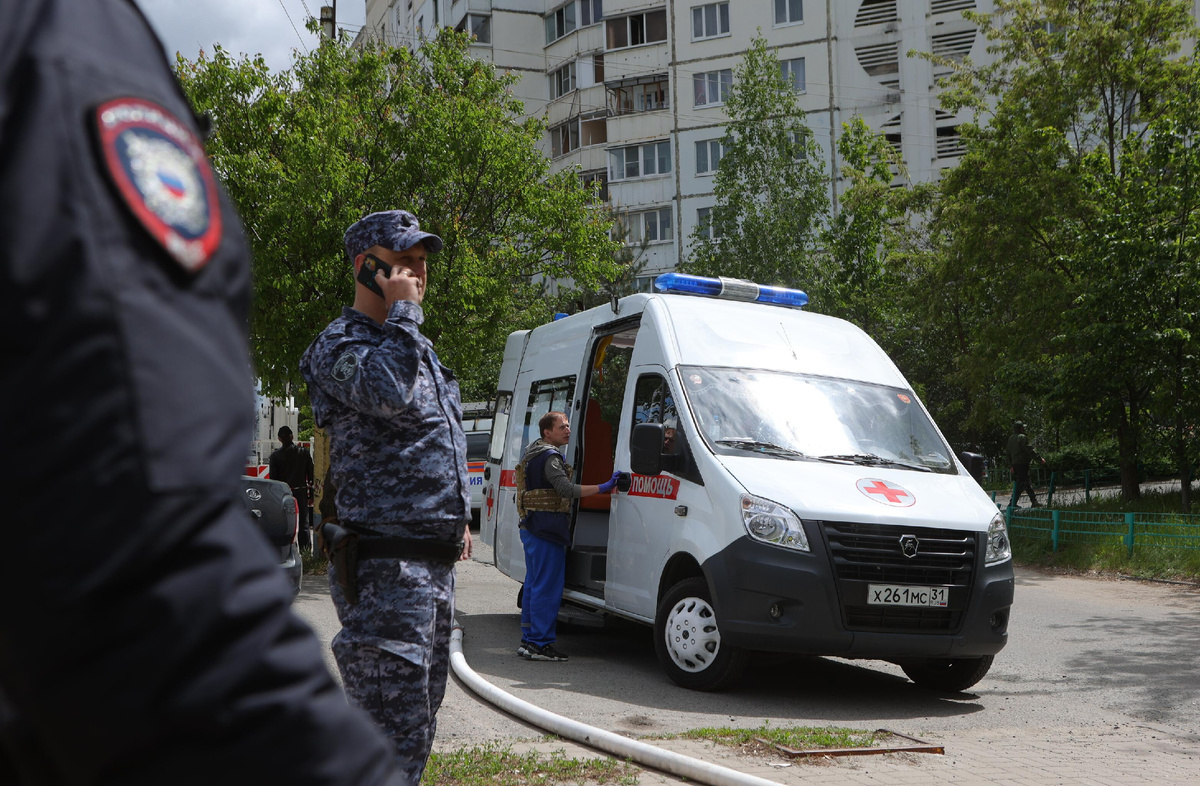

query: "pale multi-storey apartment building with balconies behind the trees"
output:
360 0 994 276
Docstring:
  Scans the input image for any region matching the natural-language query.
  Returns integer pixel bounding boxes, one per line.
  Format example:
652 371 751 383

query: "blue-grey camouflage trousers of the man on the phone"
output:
329 559 455 786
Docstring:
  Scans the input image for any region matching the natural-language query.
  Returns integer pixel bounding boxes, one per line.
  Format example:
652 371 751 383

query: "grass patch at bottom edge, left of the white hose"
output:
421 745 642 786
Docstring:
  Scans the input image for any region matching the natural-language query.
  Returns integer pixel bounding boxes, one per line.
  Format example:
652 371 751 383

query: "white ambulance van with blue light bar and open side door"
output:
481 274 1013 691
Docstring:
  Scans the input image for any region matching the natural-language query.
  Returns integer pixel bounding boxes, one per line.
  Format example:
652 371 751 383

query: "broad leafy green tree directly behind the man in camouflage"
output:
176 30 618 400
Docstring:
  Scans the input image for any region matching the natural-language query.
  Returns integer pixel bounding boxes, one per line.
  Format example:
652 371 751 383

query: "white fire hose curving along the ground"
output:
450 622 780 786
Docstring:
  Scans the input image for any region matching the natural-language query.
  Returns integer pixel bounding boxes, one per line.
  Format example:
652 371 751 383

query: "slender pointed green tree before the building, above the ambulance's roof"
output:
680 34 828 288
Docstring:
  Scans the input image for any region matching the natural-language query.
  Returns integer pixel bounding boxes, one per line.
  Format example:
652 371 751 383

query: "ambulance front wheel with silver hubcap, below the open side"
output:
654 577 749 690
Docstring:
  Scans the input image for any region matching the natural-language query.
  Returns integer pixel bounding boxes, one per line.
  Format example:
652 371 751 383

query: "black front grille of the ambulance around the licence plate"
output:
821 522 979 634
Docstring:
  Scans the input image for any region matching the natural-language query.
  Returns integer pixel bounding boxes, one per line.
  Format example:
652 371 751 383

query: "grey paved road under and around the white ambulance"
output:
298 547 1200 785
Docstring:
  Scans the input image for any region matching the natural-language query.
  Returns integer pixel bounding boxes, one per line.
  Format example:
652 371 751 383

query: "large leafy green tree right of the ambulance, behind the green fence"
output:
916 0 1195 498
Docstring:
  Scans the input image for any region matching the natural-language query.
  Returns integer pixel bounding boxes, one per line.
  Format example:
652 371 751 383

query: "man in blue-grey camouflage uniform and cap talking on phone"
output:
300 210 470 784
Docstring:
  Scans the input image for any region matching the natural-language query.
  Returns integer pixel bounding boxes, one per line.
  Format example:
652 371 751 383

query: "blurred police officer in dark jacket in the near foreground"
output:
0 0 404 786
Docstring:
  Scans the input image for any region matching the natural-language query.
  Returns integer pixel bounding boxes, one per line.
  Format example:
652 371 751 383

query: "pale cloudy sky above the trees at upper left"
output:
134 0 366 71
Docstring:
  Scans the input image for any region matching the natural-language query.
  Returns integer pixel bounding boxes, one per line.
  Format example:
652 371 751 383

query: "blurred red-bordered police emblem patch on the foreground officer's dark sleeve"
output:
95 98 221 272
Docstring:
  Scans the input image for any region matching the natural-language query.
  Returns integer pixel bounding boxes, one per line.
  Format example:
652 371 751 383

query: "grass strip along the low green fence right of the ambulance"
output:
1013 491 1200 582
